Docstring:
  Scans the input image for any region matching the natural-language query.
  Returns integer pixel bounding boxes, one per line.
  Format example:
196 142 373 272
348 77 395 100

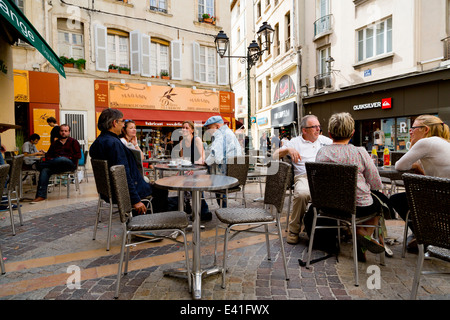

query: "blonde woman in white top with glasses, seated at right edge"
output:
389 115 450 251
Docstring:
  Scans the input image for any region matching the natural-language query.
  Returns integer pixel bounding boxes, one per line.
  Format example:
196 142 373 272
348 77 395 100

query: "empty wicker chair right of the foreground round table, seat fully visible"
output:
214 162 291 288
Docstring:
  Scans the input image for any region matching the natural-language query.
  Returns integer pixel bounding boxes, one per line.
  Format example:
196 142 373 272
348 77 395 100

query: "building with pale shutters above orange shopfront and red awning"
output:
13 0 234 158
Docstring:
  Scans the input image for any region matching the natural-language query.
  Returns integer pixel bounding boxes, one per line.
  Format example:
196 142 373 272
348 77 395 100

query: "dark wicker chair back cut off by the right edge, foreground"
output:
403 173 450 299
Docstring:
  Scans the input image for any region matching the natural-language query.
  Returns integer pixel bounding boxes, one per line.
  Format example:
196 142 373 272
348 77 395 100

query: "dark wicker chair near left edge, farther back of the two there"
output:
3 154 24 235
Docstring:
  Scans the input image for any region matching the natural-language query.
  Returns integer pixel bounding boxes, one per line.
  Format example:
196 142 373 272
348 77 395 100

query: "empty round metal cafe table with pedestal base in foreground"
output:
155 174 239 299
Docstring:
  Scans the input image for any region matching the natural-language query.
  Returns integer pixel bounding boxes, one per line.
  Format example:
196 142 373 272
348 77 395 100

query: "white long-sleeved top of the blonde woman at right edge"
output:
395 137 450 178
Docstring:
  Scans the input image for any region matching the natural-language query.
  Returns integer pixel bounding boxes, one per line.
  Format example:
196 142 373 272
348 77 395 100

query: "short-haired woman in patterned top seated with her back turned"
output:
316 112 385 261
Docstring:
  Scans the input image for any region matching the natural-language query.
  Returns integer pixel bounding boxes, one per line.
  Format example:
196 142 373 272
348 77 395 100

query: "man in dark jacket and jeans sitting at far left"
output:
31 124 81 203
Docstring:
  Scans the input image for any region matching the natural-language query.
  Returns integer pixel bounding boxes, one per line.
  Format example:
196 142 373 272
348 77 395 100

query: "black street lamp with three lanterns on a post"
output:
214 22 275 153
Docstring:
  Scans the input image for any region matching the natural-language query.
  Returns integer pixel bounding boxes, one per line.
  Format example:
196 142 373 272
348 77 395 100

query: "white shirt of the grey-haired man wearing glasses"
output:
281 135 333 176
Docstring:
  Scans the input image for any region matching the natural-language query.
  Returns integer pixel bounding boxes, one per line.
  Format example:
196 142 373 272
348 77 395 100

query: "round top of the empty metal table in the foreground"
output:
155 174 239 191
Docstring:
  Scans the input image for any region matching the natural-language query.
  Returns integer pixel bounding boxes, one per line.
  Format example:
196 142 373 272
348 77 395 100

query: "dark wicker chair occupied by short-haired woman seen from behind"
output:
305 162 384 286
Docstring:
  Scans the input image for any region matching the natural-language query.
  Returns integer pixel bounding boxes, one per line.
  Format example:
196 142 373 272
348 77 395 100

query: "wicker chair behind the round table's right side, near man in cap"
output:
214 156 250 208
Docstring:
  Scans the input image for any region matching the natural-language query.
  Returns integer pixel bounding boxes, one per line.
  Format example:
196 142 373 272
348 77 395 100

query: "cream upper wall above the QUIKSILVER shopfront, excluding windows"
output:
303 0 449 95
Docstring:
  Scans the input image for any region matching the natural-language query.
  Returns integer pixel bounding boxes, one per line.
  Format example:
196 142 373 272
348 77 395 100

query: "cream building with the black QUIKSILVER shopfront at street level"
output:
302 0 450 151
